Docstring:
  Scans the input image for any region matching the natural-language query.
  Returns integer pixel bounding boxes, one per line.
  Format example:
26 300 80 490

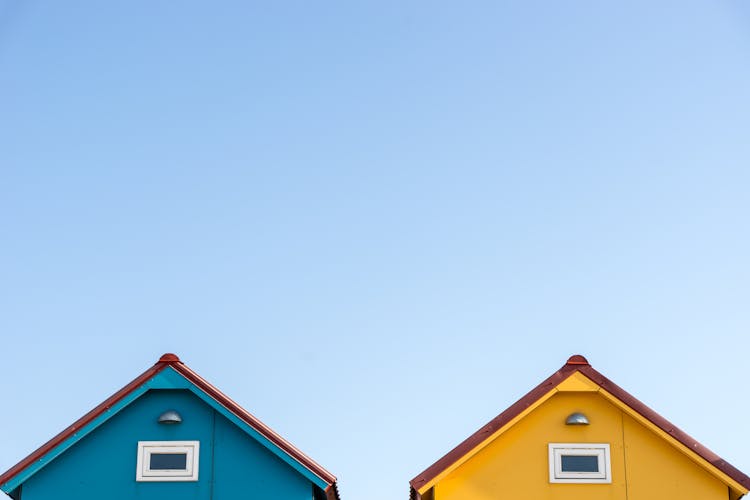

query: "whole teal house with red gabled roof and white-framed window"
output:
0 354 340 500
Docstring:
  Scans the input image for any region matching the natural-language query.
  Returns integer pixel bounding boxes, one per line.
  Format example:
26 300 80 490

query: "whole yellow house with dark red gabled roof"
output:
410 355 750 500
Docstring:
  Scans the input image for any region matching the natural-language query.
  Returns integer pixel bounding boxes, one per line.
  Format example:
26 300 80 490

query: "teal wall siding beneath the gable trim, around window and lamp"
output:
16 389 313 500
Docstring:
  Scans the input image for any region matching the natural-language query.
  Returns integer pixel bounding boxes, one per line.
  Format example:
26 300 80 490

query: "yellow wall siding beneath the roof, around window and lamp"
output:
434 390 728 500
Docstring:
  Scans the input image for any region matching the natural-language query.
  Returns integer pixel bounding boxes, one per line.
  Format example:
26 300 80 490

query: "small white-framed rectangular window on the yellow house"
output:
549 443 612 483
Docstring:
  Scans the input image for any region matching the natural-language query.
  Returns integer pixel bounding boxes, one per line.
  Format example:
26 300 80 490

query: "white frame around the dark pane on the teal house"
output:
135 441 200 482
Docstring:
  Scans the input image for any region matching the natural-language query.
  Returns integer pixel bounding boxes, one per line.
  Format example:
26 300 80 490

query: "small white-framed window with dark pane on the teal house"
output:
135 441 200 481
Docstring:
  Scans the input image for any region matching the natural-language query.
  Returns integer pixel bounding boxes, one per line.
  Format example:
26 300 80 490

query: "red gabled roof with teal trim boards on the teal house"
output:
0 353 339 500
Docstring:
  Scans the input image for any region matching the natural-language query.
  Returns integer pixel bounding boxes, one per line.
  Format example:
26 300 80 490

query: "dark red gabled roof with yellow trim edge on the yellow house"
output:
409 355 750 499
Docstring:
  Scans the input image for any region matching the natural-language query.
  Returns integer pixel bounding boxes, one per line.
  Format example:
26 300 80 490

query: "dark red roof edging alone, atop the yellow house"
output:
409 354 750 498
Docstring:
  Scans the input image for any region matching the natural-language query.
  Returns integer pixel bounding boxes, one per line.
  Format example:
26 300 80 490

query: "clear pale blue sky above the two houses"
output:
0 0 750 500
